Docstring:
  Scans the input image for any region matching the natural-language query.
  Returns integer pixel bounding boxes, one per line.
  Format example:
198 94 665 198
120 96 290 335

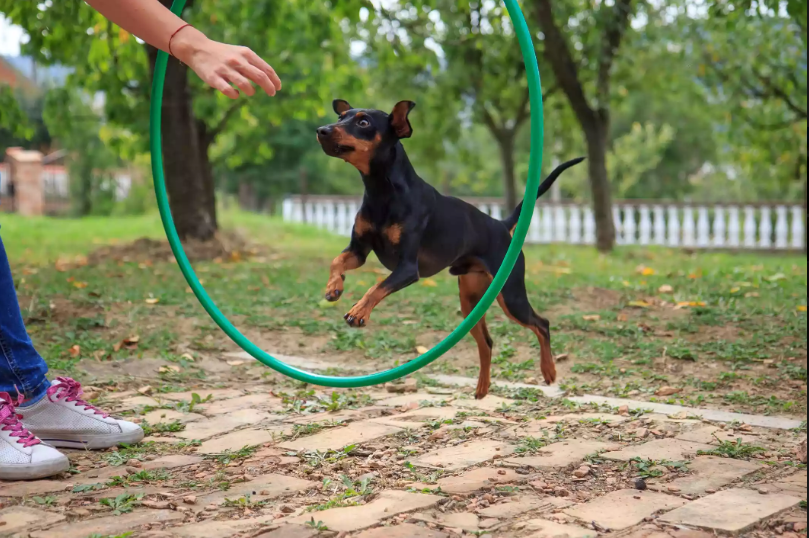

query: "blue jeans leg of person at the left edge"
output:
0 229 50 404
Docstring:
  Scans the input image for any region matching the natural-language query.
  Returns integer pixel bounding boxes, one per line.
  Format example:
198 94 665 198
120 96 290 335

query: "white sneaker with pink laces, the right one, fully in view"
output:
17 377 144 450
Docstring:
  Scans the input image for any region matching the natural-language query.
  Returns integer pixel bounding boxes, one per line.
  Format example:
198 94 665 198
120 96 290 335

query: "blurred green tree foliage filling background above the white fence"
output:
0 0 807 241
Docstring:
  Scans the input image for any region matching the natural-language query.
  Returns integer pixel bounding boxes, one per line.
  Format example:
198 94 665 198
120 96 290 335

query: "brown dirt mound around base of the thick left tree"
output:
87 231 261 265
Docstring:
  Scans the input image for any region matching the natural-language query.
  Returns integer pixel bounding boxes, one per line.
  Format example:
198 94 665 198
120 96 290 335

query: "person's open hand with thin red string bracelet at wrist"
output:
171 26 281 99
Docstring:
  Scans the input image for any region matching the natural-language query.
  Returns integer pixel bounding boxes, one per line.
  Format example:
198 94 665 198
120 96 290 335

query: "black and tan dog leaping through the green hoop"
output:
317 100 583 398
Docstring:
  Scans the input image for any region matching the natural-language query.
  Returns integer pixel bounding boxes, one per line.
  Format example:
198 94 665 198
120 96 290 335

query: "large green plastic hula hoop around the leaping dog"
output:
149 0 545 388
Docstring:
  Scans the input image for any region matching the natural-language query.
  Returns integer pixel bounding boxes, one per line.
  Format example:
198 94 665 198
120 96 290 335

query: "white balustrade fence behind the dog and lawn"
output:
283 196 806 251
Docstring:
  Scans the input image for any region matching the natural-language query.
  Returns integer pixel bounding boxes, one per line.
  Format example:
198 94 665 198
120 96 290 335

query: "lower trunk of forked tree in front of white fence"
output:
583 120 615 252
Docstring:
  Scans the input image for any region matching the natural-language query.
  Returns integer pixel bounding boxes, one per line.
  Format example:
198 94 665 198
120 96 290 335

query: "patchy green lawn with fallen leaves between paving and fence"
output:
0 213 807 416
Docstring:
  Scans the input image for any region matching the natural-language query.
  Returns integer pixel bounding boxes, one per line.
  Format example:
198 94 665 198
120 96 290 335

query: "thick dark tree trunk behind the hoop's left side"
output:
147 47 217 241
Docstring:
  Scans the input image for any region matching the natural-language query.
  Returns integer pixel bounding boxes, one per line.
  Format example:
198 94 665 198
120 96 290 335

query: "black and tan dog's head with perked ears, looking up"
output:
317 99 416 175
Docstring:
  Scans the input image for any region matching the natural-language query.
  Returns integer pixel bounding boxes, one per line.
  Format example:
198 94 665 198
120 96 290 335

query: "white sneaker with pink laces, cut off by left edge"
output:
0 392 70 480
